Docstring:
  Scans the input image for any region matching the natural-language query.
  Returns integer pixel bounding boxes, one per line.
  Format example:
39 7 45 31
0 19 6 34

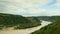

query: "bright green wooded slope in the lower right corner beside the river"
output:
31 16 60 34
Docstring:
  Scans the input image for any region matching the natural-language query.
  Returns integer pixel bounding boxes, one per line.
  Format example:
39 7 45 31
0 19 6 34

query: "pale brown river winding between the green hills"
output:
0 21 52 34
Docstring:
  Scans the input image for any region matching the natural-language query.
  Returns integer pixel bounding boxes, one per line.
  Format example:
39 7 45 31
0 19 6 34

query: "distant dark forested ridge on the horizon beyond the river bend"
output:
31 16 60 22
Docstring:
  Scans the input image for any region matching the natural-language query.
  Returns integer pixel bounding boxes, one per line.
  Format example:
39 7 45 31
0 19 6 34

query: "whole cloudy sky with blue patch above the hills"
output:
0 0 60 16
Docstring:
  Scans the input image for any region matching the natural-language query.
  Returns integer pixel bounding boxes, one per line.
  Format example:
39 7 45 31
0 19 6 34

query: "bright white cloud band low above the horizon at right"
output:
29 9 60 16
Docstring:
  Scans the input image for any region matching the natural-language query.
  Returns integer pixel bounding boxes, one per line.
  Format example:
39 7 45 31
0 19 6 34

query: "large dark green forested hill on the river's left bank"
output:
0 13 40 29
